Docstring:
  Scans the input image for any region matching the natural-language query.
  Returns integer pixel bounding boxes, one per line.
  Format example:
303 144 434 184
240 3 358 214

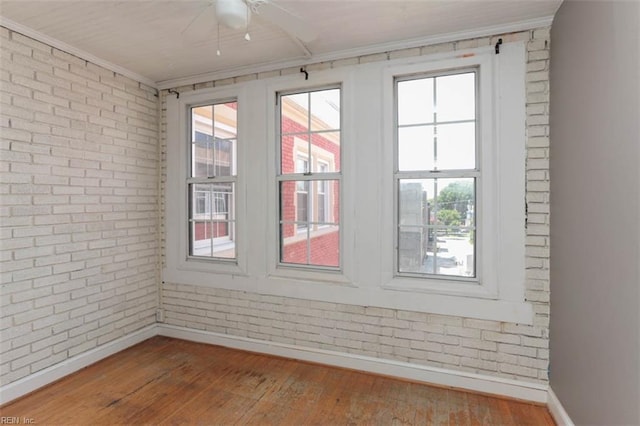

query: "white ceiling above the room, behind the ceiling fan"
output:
0 0 562 87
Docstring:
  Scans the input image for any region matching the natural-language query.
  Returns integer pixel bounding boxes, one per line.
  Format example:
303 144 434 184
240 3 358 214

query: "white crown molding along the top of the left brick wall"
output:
0 16 158 89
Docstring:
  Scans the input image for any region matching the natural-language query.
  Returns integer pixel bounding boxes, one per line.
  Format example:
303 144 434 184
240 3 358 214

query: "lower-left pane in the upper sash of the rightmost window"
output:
398 126 435 171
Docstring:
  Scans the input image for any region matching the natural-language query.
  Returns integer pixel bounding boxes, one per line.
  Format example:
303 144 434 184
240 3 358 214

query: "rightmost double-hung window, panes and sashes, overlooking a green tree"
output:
394 70 480 280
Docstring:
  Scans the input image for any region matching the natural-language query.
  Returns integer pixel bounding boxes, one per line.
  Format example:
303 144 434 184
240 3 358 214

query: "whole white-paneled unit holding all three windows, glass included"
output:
162 42 535 324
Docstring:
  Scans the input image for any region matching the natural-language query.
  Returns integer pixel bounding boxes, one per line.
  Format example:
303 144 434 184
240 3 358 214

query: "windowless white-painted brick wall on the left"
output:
0 28 159 385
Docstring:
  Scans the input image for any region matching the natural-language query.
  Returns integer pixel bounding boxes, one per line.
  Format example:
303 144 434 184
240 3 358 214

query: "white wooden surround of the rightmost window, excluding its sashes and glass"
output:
381 44 530 310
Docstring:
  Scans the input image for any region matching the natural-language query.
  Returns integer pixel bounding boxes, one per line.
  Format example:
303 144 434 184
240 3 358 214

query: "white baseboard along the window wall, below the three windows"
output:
158 324 548 403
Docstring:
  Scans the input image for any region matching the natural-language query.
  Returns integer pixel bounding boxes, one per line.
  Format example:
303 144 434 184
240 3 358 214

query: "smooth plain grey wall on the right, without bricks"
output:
550 1 640 425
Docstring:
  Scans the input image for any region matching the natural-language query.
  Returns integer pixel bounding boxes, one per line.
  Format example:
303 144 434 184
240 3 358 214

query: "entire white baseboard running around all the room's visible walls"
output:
0 323 552 408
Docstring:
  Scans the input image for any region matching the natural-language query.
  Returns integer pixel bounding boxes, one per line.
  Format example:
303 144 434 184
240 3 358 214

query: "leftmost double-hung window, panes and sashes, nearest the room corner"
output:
187 101 238 260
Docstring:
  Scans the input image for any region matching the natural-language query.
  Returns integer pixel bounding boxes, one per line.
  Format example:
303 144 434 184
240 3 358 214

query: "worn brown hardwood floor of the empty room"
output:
0 337 554 425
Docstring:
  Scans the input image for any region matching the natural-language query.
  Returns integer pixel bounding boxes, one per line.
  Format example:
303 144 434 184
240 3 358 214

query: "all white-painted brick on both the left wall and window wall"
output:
0 28 549 385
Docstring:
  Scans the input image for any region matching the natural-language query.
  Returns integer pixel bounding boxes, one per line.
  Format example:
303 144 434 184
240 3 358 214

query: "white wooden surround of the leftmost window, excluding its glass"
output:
164 87 247 282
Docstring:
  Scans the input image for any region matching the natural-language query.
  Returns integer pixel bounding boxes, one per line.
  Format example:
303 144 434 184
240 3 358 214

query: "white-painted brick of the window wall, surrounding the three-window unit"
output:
160 28 549 383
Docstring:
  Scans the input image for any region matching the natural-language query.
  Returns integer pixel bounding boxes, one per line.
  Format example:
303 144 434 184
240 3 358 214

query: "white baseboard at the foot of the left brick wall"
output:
0 324 158 405
